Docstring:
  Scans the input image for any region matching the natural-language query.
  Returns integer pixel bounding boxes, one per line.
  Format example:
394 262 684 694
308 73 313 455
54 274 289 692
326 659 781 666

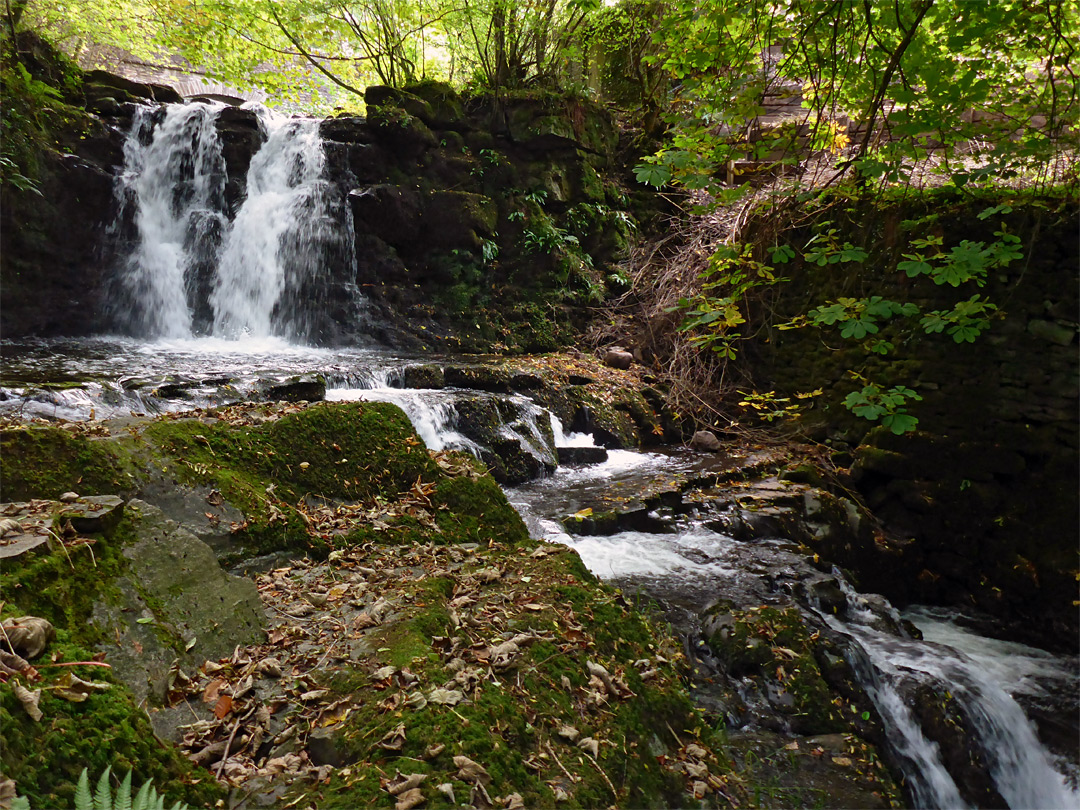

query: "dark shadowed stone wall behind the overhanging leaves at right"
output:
748 193 1080 646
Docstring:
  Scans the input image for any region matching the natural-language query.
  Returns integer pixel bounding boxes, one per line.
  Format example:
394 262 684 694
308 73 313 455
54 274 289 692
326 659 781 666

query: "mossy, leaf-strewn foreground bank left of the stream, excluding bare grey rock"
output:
0 403 894 808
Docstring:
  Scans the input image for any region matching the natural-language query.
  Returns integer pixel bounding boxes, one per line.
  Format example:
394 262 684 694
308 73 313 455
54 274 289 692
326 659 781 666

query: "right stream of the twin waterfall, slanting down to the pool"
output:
211 109 334 338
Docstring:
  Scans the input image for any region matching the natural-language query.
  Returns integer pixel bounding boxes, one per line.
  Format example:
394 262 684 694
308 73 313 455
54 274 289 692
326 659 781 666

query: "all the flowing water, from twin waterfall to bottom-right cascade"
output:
0 98 1080 808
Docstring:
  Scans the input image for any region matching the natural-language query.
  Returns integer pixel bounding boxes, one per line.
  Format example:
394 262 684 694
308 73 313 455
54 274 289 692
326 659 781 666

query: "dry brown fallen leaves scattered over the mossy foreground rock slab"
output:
156 466 756 810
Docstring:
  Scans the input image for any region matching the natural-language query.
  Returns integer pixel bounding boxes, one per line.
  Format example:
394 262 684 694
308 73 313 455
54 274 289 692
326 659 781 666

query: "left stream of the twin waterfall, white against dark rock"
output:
117 104 227 338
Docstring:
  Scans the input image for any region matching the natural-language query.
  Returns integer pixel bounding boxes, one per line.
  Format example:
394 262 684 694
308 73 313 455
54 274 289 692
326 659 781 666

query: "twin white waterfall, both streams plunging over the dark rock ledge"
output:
113 104 355 340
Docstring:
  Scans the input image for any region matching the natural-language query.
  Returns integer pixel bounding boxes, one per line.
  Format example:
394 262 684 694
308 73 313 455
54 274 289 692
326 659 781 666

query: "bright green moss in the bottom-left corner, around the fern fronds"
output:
0 630 224 808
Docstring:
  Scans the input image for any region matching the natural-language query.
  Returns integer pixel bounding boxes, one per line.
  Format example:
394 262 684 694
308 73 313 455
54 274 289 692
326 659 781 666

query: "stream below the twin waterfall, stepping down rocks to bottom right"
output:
0 338 1080 808
